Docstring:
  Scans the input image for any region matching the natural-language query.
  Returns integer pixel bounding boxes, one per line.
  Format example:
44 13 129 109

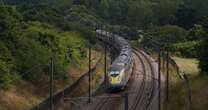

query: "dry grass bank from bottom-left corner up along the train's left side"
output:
0 50 102 110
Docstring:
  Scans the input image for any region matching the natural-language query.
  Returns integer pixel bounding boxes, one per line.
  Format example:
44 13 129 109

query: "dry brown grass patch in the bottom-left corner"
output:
0 81 43 110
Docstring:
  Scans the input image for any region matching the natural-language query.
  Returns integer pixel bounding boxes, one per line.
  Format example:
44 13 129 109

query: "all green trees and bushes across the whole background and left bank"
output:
0 0 208 87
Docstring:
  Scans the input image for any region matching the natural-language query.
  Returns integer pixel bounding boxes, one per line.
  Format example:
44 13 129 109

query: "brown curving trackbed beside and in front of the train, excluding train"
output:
73 49 158 110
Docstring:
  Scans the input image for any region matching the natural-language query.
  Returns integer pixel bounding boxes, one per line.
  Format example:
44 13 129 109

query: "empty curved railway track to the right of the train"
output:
130 48 155 110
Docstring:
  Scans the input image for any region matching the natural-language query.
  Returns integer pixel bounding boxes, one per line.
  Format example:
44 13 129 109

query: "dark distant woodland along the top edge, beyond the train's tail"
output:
73 0 207 29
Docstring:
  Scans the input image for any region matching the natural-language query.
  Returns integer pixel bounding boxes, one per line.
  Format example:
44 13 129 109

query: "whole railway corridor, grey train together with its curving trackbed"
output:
69 30 163 110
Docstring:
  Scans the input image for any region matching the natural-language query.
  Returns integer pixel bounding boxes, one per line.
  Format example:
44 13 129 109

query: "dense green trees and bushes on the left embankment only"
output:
0 1 97 88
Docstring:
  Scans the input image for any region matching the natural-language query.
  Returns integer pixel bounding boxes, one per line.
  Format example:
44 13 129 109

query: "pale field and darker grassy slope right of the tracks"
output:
165 57 208 110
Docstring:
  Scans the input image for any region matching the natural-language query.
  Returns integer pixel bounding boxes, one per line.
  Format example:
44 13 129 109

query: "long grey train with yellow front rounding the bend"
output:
96 29 133 92
